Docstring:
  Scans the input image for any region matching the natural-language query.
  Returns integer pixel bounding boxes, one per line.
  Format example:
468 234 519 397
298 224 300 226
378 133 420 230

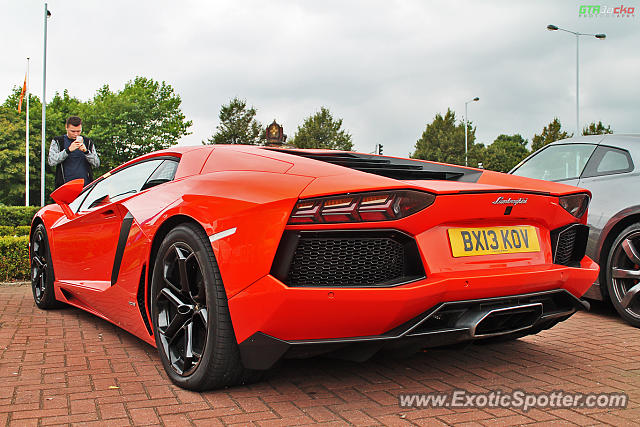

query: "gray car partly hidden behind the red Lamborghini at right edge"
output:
510 135 640 327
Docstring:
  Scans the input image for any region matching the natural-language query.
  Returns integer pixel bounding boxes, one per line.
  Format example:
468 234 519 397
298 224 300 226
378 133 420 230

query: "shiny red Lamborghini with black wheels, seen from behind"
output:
30 145 598 390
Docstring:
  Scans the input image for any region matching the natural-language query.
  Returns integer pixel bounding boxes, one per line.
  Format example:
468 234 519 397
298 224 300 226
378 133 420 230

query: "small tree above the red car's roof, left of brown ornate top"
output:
208 97 266 145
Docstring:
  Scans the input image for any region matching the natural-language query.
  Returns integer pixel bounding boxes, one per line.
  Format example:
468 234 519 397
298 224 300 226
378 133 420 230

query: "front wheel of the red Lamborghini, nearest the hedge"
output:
29 224 64 310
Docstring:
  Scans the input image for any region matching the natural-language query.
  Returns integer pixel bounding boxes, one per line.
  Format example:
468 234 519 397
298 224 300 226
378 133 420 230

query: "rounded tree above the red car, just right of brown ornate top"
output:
291 107 353 151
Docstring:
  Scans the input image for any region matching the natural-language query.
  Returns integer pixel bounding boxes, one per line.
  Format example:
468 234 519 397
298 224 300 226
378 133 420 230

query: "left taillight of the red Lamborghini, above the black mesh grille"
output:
289 190 436 224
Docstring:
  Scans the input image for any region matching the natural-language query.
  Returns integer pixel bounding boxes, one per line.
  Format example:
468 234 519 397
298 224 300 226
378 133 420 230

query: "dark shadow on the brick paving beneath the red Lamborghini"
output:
47 296 631 396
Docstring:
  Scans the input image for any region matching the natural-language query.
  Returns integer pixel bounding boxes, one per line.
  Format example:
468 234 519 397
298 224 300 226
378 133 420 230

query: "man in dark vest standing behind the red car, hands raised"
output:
49 116 100 188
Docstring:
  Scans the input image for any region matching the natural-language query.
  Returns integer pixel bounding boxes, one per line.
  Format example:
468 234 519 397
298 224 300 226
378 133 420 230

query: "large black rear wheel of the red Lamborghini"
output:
151 223 261 391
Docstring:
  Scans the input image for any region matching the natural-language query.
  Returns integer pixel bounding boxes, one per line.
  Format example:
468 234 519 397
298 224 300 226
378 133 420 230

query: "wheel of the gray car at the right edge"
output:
605 224 640 328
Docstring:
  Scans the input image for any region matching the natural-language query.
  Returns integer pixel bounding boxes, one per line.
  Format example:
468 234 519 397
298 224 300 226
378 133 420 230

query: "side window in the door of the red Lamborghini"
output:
78 159 164 212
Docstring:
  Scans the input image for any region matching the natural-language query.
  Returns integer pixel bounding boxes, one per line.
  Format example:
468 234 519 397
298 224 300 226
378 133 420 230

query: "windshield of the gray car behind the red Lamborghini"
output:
511 144 596 181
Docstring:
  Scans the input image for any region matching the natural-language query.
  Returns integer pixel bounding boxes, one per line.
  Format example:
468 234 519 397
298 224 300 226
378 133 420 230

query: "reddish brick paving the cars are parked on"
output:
0 284 640 426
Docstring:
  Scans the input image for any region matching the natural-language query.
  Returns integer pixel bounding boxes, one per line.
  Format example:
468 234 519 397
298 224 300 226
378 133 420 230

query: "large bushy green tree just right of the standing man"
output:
83 77 192 172
